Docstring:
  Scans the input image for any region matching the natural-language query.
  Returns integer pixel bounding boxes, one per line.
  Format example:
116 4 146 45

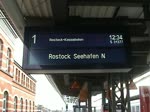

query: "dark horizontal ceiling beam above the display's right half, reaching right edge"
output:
68 16 150 25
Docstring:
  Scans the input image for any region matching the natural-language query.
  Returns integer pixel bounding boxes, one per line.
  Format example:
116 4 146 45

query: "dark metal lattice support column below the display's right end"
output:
108 74 131 112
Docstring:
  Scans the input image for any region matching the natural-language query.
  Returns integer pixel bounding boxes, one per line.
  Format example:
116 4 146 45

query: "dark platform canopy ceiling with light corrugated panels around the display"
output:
0 0 150 96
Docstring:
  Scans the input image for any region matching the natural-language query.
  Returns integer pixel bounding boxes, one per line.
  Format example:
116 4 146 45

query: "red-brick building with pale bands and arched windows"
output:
0 34 36 112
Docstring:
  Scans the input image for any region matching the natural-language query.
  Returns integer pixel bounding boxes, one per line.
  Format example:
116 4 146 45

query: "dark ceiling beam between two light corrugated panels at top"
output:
51 0 69 25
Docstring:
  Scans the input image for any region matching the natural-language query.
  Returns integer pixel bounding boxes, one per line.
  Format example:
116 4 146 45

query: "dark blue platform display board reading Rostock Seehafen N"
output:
23 27 130 70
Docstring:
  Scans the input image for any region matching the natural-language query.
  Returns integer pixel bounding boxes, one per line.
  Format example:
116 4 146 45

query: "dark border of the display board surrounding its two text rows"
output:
23 26 131 71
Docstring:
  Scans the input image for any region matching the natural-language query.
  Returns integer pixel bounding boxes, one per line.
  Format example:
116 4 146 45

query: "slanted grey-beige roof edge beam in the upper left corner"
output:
0 0 25 40
